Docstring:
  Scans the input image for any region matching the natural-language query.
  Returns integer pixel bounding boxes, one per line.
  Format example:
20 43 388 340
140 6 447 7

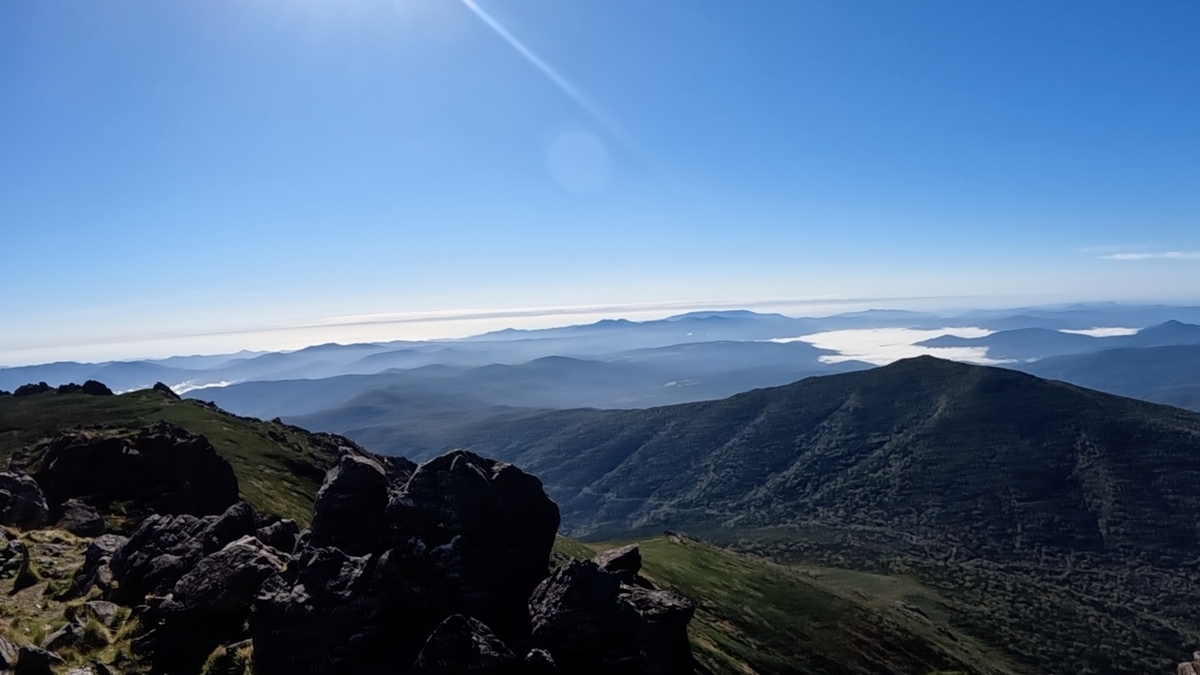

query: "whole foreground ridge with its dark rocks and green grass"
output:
0 387 1022 675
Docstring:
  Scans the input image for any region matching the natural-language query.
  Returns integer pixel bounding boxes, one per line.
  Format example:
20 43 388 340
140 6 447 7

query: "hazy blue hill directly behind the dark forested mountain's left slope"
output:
199 342 869 417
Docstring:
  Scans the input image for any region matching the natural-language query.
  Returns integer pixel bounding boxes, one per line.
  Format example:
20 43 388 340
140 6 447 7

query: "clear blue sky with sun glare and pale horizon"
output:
0 0 1200 364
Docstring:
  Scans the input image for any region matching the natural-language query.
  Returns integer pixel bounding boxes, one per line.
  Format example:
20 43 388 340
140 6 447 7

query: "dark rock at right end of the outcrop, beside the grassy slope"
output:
529 561 695 675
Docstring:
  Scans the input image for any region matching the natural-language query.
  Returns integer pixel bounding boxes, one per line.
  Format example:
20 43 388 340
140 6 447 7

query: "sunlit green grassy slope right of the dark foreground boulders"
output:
556 536 1022 675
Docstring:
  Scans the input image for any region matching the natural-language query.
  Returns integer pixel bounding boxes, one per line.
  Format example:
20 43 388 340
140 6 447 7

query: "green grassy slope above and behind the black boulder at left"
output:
0 390 336 524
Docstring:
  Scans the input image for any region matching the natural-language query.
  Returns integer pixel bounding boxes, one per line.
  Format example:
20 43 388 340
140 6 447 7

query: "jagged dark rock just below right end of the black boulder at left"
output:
109 503 257 598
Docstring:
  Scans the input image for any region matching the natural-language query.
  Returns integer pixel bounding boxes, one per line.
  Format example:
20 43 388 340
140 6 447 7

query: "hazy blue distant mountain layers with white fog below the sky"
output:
7 304 1200 418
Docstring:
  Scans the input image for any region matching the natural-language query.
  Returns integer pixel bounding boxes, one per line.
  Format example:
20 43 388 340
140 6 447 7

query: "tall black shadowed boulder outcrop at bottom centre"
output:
250 450 694 675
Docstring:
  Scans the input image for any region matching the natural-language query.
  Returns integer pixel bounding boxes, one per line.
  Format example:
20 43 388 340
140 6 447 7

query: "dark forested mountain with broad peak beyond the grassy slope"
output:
302 358 1200 673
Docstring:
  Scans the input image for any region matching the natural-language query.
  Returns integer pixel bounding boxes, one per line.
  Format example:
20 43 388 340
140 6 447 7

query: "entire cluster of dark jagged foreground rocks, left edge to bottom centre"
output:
0 424 695 675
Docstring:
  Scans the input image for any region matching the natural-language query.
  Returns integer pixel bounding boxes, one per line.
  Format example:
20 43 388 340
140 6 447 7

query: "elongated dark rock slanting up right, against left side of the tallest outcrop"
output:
139 536 286 673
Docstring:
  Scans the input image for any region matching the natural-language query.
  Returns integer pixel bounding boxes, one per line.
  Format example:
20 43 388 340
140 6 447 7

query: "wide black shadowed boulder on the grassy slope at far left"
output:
12 422 238 516
